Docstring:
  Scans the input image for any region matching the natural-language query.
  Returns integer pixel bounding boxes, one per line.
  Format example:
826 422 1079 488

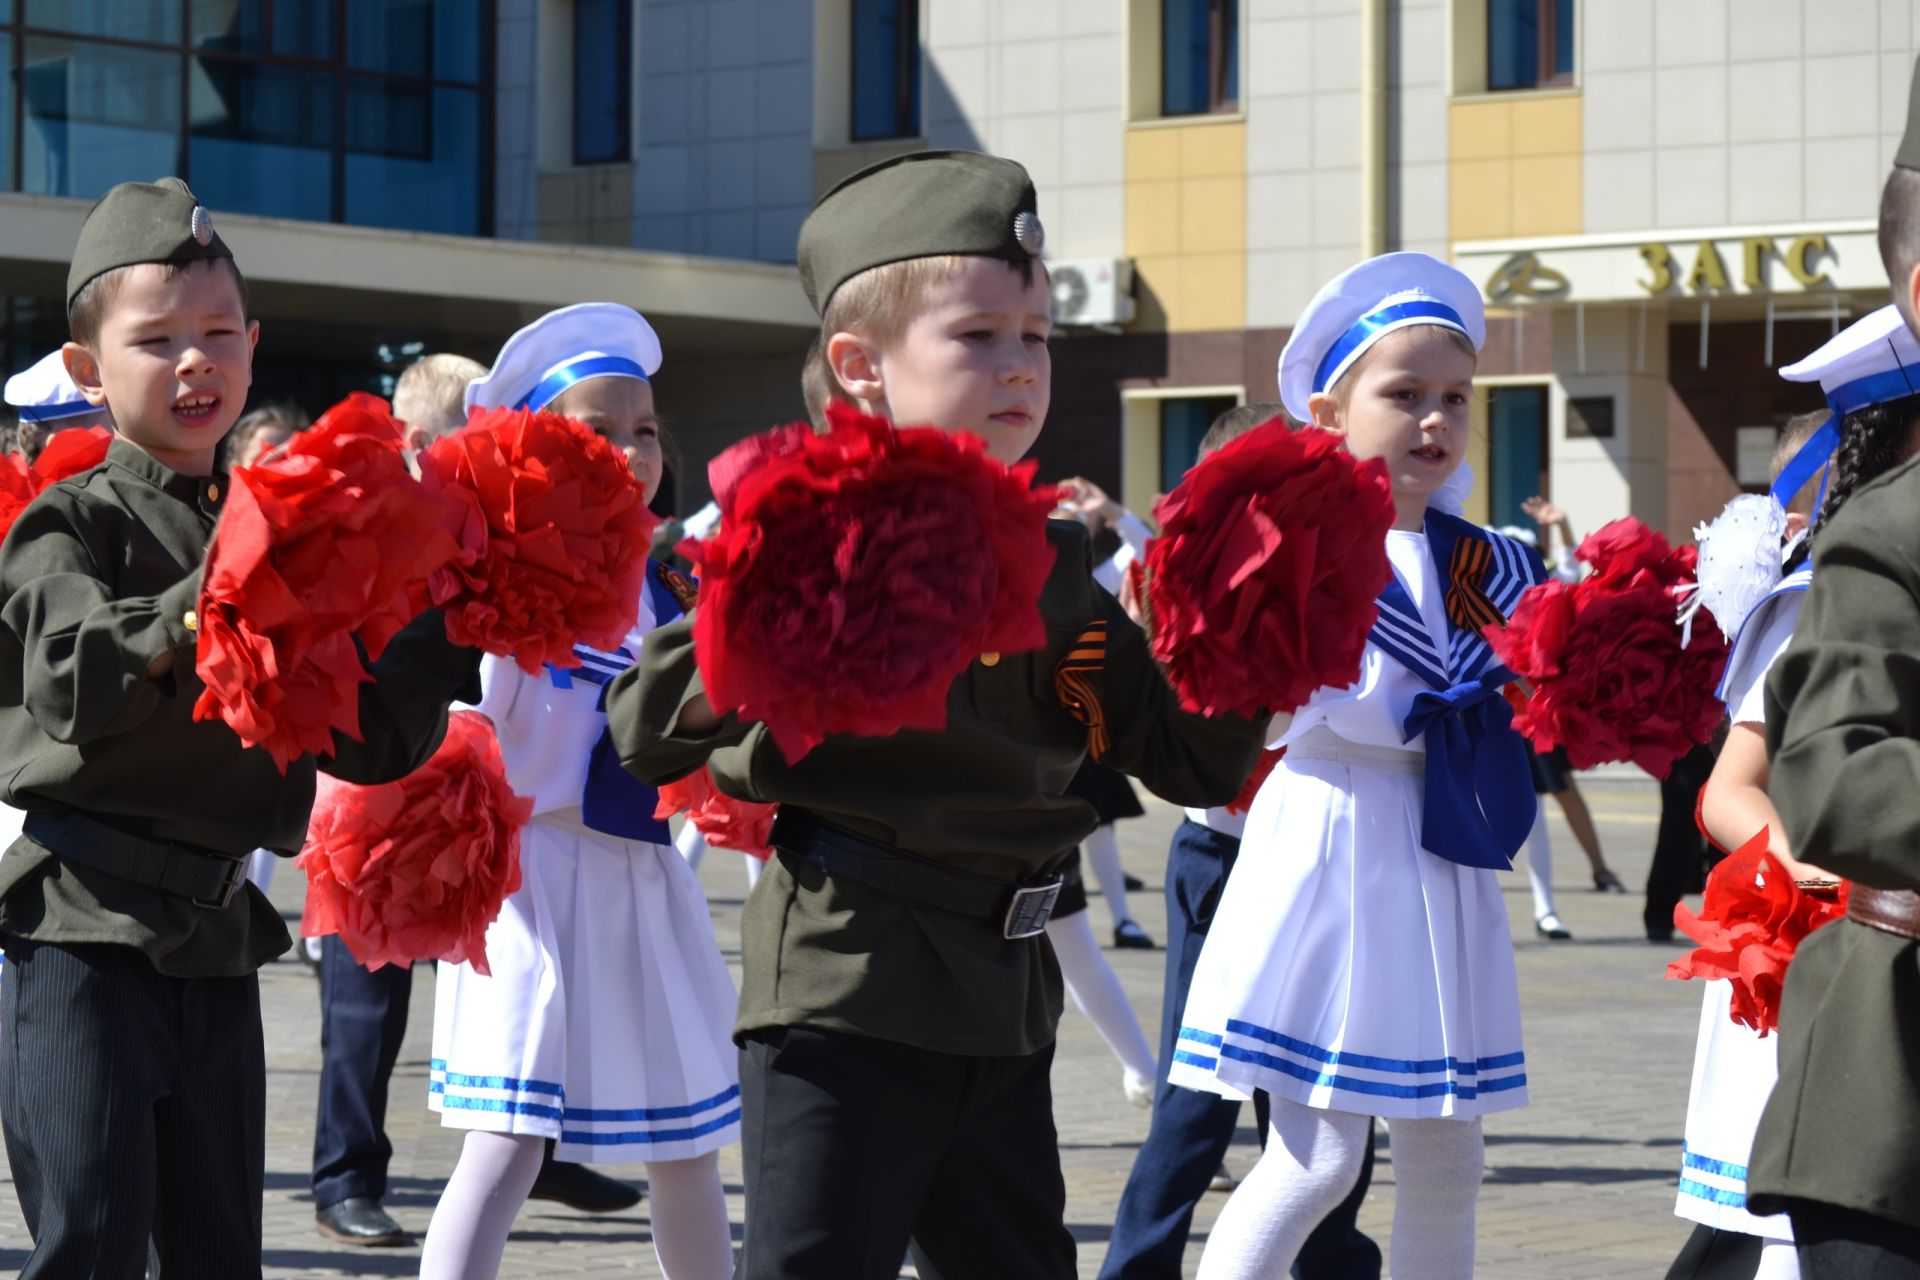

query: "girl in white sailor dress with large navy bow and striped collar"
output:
1171 253 1544 1280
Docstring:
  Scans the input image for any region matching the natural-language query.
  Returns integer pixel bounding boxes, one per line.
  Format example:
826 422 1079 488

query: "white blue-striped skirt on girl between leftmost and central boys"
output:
426 810 739 1165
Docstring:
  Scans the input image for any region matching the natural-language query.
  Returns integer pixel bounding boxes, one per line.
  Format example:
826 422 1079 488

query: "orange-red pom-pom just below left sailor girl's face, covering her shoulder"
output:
420 409 659 674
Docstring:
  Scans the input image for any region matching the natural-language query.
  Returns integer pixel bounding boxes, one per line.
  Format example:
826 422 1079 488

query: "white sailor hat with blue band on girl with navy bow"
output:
1281 253 1486 422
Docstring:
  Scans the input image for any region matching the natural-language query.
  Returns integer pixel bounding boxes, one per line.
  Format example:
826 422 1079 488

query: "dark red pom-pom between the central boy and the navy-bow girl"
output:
1146 422 1394 716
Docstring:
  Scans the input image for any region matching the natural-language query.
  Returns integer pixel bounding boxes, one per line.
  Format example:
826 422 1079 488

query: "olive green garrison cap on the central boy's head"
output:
799 152 1046 313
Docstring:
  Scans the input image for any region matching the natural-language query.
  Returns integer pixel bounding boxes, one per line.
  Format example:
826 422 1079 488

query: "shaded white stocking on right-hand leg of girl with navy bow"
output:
1386 1117 1486 1280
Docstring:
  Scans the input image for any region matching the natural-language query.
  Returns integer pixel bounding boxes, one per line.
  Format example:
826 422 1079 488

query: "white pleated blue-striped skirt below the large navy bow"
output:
1171 729 1526 1119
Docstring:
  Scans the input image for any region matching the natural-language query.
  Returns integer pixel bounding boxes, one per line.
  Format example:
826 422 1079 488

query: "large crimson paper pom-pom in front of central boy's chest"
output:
682 405 1054 760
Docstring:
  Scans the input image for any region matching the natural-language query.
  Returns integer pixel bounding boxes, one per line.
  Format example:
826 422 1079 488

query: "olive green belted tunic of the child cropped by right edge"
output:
1747 452 1920 1228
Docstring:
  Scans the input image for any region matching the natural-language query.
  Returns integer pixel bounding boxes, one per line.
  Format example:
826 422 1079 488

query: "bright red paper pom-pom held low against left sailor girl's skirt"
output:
296 712 534 973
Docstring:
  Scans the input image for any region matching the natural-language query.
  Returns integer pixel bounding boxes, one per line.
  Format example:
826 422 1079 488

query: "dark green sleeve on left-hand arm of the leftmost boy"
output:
0 497 200 747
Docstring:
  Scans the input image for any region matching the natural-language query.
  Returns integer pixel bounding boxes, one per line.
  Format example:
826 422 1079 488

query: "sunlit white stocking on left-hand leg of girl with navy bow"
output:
1200 1098 1374 1280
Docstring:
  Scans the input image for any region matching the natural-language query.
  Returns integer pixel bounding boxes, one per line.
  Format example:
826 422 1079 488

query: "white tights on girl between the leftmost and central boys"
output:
420 1130 733 1280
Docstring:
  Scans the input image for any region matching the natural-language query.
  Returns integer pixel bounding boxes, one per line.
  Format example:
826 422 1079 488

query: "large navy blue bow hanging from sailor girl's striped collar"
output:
1402 666 1538 871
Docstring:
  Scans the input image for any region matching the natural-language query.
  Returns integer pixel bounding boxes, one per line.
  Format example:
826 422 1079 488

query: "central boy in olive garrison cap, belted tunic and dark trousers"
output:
607 152 1260 1280
